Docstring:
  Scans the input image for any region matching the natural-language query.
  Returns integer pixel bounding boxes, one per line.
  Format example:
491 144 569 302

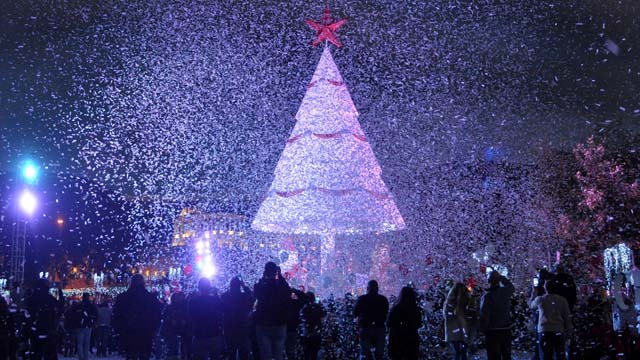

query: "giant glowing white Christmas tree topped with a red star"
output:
252 9 404 269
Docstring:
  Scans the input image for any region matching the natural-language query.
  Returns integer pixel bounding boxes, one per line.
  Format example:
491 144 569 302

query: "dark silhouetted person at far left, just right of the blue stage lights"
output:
25 279 63 360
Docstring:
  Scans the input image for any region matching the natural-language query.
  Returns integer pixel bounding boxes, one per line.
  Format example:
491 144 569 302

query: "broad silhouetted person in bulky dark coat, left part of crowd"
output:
113 274 161 360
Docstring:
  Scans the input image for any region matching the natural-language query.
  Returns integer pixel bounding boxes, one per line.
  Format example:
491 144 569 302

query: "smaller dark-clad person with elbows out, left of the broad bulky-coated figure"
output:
65 293 98 360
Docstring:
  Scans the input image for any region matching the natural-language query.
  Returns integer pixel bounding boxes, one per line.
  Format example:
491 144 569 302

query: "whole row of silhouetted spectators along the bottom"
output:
0 262 638 360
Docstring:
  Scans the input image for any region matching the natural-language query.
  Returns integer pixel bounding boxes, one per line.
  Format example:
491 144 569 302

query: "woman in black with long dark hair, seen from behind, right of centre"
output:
387 286 422 360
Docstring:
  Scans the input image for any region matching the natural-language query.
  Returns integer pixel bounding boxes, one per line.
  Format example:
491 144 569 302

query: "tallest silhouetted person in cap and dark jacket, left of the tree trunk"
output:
253 262 291 360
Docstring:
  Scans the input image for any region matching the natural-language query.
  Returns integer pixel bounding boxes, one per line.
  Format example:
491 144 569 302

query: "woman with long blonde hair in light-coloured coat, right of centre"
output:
442 283 470 360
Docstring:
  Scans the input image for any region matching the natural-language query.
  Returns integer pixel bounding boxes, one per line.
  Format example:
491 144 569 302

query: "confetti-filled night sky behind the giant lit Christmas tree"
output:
0 0 640 282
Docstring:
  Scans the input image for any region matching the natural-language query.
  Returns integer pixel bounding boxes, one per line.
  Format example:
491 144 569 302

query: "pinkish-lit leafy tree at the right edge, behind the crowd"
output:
558 137 640 277
